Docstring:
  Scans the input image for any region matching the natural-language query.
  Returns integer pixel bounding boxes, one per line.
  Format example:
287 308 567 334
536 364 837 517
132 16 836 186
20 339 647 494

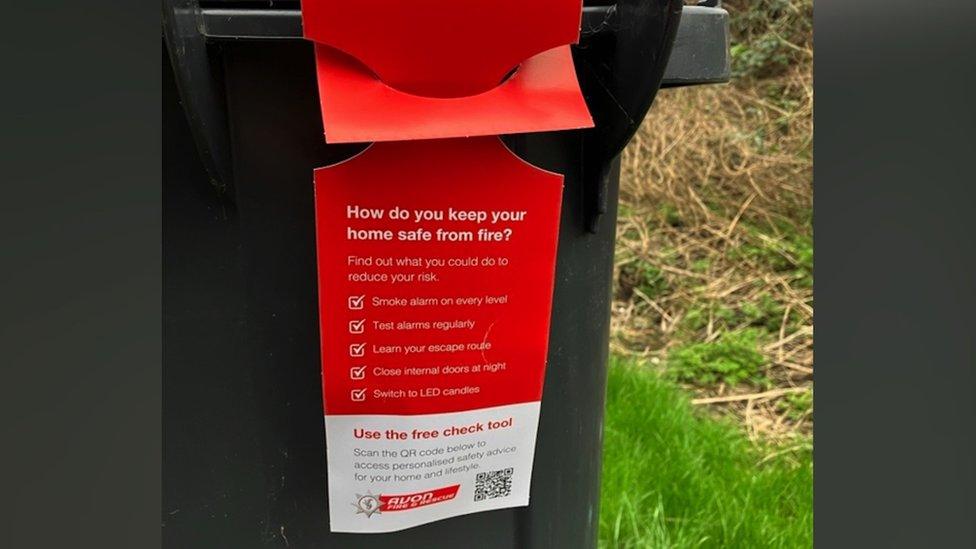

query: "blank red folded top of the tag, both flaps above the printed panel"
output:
302 0 593 143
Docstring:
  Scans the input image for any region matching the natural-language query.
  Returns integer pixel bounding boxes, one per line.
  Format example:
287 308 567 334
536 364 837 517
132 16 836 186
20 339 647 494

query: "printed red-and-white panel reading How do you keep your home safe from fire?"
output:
315 137 562 532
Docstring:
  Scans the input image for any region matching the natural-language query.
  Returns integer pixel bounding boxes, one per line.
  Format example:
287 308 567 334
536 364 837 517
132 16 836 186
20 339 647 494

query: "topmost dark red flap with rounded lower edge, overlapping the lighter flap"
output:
302 0 583 97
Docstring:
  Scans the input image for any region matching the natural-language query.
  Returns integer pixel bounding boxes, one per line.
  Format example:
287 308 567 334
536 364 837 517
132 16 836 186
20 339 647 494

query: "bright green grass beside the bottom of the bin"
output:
600 358 813 549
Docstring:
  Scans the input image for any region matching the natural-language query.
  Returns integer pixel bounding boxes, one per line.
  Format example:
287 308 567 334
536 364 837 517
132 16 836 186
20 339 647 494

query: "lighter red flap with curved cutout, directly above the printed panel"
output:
315 44 593 143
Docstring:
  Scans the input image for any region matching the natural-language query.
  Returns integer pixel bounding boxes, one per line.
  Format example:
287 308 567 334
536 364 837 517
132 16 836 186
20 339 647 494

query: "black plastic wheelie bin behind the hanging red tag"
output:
162 0 708 548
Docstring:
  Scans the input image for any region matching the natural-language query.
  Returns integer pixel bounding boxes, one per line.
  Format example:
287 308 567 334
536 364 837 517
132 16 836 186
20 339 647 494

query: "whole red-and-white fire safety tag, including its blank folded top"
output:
302 0 593 533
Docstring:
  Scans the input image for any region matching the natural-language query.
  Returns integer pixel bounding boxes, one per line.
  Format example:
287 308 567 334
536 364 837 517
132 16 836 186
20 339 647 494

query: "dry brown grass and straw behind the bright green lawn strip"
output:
612 0 813 441
